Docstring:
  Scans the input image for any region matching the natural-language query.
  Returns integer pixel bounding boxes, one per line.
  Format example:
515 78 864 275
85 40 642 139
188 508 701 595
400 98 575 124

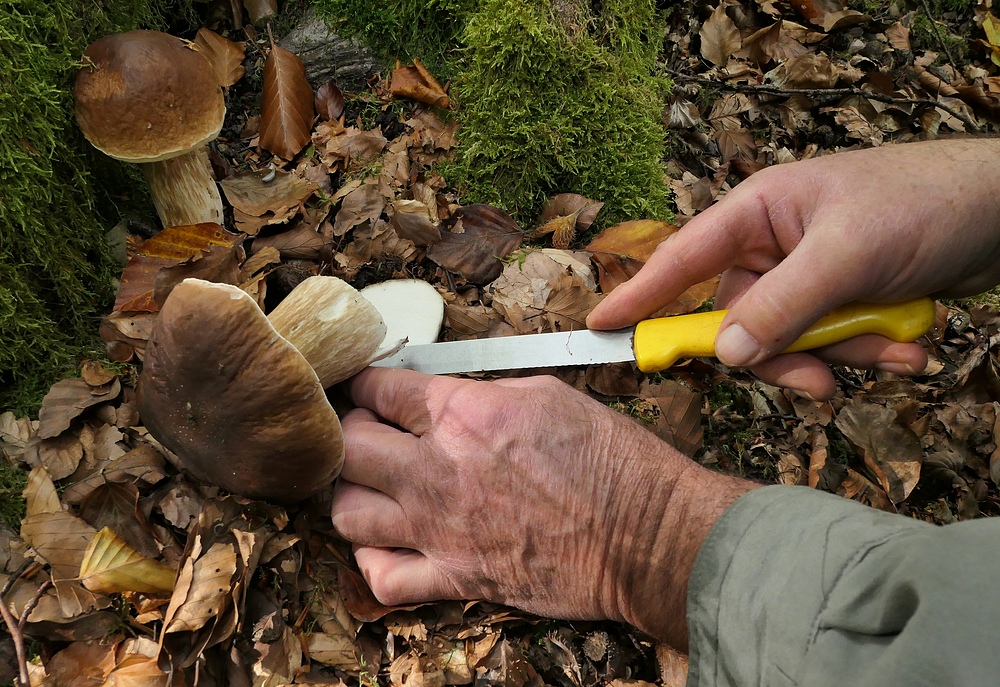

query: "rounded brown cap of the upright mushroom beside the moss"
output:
74 31 226 163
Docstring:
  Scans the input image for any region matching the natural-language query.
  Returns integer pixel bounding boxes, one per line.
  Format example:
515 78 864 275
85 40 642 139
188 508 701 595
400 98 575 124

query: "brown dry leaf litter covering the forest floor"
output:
0 0 1000 687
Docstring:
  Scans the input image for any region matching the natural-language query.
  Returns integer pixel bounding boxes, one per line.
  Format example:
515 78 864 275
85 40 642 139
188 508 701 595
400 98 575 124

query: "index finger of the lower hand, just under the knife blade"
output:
347 367 460 436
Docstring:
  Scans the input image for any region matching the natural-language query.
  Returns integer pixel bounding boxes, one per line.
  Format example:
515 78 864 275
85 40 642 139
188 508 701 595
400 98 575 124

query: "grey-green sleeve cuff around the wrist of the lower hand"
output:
687 486 933 687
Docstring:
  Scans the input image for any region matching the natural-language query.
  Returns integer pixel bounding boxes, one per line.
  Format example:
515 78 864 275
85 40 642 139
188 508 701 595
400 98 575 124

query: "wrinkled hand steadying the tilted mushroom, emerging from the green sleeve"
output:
332 368 752 647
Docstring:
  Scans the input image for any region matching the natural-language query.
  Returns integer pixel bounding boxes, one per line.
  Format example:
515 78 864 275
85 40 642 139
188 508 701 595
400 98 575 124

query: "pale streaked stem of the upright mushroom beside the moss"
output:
142 145 222 228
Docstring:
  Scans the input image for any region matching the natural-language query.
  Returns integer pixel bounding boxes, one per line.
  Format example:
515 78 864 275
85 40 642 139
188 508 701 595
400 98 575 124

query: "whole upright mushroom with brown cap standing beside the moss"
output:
74 31 226 227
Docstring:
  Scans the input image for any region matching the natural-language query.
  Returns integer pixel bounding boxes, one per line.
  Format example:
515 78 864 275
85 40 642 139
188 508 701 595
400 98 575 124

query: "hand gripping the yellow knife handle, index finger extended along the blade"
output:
587 139 1000 399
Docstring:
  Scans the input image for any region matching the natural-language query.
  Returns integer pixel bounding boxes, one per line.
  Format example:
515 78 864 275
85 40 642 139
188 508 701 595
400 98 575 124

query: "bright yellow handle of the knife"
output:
632 298 934 372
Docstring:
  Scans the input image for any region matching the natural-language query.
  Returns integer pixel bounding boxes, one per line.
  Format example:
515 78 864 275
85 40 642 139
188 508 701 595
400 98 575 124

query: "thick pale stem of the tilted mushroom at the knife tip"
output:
267 277 385 388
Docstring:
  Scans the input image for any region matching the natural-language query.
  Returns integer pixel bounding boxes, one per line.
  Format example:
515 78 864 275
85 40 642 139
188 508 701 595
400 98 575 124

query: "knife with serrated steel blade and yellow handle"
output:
372 298 934 374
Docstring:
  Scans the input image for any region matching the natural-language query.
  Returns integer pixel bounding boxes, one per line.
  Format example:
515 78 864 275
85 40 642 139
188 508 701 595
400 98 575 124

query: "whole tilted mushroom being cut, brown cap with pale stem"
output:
138 277 385 503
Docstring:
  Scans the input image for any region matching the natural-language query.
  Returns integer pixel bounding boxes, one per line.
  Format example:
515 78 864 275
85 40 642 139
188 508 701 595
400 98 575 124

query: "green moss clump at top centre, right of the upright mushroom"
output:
317 0 670 228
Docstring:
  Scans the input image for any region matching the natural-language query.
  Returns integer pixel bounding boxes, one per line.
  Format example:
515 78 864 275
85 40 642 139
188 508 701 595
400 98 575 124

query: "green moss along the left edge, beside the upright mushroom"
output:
0 0 184 411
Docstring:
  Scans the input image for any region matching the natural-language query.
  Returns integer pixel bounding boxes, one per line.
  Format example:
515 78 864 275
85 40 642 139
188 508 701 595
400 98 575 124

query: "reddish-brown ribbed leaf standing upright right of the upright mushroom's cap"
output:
259 43 313 160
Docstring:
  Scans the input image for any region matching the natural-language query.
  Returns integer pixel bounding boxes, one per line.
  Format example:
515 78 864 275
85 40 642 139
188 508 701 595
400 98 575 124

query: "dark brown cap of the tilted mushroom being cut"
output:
138 279 344 503
